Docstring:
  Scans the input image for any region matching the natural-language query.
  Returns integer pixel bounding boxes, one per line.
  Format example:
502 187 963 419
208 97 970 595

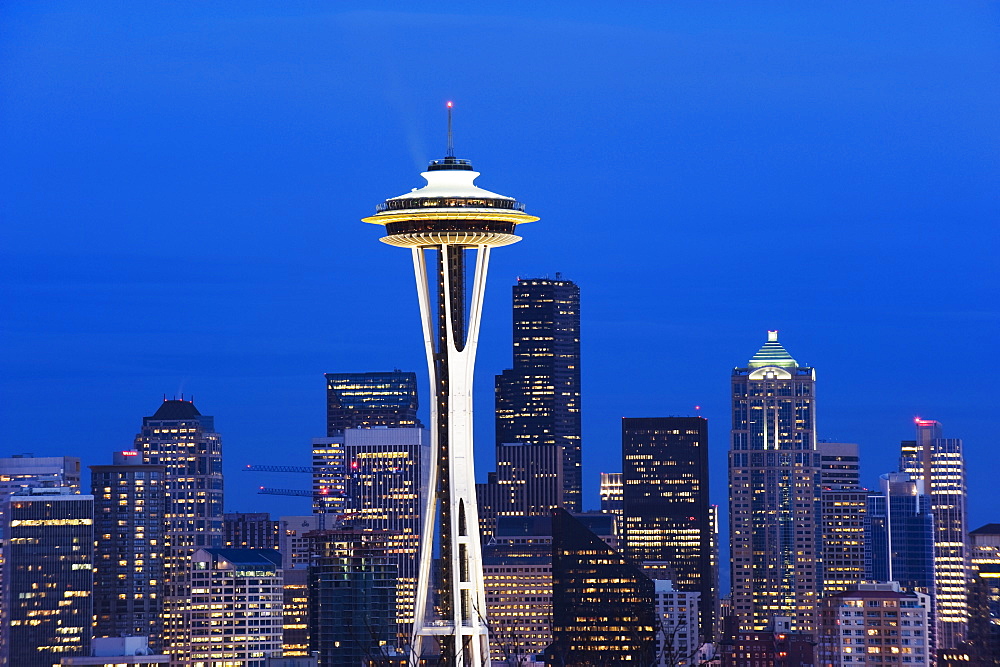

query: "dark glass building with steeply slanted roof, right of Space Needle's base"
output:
546 509 657 666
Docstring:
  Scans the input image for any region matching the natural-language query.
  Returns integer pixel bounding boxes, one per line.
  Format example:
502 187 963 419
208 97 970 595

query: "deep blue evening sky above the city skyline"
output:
0 0 1000 542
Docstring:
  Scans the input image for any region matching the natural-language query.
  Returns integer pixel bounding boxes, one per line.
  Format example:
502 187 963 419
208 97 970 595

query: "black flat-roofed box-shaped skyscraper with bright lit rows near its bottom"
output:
621 417 718 640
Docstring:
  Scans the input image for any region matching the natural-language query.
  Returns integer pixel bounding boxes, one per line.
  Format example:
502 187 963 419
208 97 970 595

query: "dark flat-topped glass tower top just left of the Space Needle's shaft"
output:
326 371 421 437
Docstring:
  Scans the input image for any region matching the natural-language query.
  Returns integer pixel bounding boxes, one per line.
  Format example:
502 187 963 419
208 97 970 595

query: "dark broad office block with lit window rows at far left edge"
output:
0 487 94 667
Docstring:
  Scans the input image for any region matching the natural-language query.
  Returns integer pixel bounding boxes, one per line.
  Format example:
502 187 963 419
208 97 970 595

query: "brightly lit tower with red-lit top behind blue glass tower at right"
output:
899 419 969 649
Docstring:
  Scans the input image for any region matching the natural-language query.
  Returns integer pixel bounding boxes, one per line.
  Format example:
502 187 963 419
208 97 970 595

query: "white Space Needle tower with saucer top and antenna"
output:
363 102 538 667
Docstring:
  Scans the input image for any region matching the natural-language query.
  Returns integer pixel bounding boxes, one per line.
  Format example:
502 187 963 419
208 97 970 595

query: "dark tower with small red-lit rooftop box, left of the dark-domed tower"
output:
90 450 167 651
